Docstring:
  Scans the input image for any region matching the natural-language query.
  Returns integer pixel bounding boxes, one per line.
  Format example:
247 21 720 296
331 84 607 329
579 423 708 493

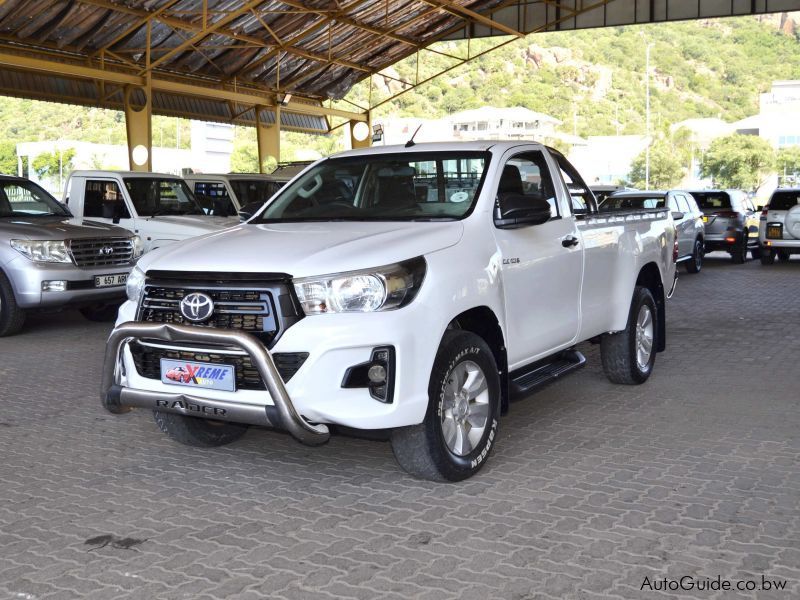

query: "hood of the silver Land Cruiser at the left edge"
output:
0 217 131 240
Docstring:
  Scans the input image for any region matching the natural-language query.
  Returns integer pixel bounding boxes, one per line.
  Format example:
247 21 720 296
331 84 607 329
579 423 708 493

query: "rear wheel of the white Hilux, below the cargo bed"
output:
600 286 658 385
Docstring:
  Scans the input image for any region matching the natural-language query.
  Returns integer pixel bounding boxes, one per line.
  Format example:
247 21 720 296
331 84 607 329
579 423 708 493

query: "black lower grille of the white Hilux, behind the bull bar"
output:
130 342 308 390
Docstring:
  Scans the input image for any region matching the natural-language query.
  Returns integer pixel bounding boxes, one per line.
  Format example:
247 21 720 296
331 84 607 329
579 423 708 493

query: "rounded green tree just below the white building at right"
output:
700 134 775 190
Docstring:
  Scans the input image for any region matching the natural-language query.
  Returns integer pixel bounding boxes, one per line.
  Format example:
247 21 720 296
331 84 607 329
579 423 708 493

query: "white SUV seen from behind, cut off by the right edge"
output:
758 188 800 265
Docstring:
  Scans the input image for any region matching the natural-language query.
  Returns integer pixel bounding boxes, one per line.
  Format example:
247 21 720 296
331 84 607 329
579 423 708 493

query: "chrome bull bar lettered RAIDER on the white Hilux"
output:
100 322 330 446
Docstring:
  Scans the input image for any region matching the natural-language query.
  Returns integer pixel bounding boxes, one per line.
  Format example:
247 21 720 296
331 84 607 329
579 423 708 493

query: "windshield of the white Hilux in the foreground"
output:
253 152 490 223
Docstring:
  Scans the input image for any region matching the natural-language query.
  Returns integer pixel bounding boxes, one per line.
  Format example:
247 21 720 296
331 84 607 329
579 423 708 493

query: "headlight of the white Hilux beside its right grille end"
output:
294 257 426 315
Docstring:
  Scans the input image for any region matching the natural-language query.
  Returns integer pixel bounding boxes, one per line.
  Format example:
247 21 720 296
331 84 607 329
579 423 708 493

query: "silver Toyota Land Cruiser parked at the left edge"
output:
0 176 142 336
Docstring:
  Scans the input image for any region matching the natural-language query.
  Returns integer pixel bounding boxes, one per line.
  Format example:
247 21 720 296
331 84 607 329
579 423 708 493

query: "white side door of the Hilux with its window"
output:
495 150 583 369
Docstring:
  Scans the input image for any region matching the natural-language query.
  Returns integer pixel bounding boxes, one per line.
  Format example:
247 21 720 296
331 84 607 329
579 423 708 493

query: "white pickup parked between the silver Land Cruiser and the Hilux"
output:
64 171 239 252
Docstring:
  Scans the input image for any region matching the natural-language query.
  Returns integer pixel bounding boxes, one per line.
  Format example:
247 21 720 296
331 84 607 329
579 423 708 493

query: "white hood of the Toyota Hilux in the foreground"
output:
139 221 464 277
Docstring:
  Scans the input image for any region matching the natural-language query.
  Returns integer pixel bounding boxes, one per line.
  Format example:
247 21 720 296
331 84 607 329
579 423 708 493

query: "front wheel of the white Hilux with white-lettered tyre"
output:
391 330 500 481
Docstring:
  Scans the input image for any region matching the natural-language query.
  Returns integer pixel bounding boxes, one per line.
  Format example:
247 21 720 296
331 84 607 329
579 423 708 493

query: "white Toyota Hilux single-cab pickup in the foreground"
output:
101 142 677 480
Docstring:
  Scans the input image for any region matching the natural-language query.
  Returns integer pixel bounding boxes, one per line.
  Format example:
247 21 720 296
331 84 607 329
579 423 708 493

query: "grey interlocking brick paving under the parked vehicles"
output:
0 257 800 600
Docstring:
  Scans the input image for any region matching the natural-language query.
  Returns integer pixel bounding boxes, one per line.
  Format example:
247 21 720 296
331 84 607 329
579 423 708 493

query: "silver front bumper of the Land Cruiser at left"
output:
4 258 133 308
